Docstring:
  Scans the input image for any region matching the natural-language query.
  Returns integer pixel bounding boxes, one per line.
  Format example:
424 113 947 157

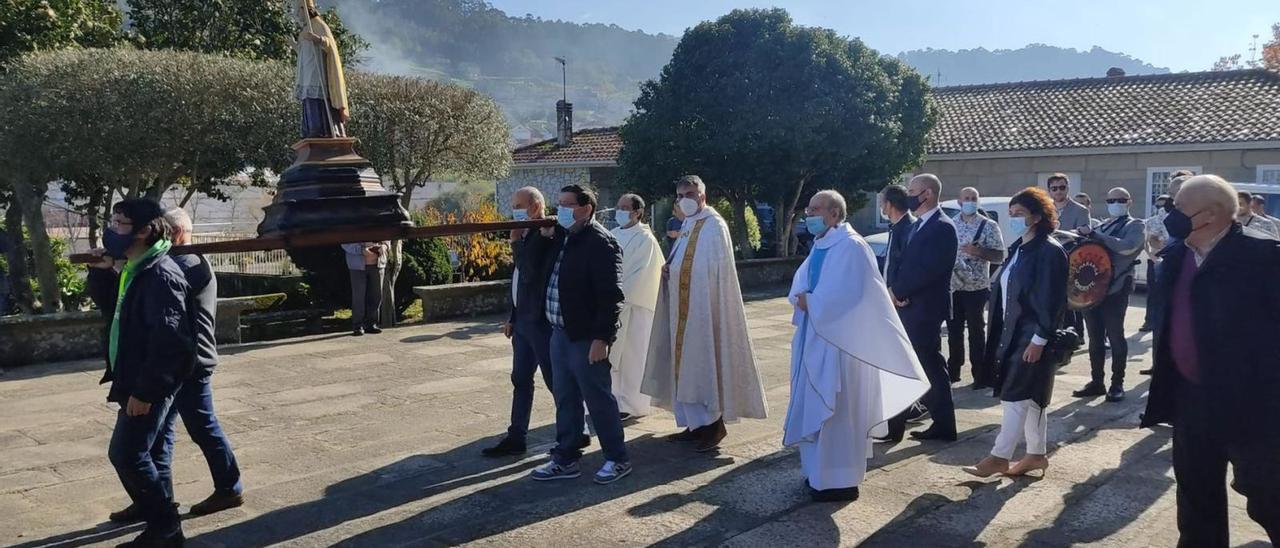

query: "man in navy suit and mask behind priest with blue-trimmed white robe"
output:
888 173 959 440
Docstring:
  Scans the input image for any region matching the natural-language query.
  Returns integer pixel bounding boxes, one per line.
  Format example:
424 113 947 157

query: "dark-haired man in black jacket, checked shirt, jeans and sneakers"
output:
532 184 631 484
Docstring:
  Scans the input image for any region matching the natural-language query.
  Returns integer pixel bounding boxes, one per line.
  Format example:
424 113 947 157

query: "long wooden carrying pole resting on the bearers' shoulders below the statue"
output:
68 219 556 264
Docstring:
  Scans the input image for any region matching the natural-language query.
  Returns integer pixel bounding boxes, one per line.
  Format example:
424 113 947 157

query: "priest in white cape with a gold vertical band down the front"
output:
640 175 767 452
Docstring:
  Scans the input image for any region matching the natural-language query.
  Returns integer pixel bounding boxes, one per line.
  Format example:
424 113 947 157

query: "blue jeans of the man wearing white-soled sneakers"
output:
552 328 630 465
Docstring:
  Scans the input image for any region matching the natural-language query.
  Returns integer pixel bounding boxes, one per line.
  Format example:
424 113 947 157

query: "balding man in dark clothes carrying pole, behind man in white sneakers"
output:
480 187 554 457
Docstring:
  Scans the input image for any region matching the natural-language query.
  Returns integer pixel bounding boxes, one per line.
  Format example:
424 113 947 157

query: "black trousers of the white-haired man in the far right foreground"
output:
1174 382 1280 548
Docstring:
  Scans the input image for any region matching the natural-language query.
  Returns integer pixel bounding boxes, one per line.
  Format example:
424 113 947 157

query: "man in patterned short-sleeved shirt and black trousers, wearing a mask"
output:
947 187 1005 391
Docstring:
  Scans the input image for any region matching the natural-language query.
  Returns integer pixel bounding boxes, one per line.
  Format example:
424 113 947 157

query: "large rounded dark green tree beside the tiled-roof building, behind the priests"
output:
618 9 936 256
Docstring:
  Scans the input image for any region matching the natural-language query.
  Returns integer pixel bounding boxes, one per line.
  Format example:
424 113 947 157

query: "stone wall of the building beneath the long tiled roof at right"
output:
915 147 1280 216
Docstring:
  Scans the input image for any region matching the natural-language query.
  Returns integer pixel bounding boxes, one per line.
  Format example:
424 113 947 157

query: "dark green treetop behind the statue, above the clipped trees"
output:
128 0 369 67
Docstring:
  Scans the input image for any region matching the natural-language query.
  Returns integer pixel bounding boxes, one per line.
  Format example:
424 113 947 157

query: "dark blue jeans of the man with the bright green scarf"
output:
106 397 180 534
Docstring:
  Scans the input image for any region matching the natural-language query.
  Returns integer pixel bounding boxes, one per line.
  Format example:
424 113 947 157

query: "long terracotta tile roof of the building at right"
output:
928 70 1280 154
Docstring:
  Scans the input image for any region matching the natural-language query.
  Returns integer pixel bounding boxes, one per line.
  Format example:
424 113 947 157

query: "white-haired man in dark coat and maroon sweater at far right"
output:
1142 175 1280 547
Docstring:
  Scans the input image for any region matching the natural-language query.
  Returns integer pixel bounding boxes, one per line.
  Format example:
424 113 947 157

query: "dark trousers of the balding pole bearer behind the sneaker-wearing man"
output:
507 321 554 442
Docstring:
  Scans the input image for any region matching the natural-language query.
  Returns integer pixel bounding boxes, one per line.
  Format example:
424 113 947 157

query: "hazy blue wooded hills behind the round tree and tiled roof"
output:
321 0 1169 137
